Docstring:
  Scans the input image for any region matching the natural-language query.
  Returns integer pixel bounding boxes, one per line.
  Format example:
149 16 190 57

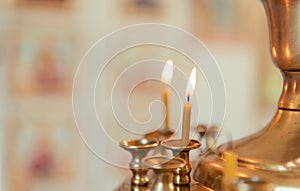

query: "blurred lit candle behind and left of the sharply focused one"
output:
161 60 173 130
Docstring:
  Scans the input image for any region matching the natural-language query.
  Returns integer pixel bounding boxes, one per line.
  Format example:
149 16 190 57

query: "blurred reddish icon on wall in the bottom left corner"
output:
6 119 78 191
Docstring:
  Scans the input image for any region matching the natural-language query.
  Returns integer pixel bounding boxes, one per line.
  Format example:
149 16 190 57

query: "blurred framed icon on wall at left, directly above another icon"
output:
9 30 76 94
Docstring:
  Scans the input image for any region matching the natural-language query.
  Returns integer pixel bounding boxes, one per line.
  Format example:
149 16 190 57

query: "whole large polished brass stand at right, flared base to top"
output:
194 0 300 190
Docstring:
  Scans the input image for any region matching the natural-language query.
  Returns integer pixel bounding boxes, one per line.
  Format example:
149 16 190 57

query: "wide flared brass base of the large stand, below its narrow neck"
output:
194 109 300 190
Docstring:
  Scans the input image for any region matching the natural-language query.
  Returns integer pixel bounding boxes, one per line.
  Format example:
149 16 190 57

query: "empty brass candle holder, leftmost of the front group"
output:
120 139 159 186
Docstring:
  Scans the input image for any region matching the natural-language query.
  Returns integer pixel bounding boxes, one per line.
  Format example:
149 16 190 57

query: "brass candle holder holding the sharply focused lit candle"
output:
161 139 201 186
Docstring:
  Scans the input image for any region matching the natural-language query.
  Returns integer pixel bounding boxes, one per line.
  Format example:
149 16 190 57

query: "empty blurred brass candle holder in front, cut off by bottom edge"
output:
143 156 185 191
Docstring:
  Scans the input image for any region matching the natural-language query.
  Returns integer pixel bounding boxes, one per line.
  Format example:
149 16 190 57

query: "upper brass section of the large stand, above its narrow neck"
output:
262 0 300 71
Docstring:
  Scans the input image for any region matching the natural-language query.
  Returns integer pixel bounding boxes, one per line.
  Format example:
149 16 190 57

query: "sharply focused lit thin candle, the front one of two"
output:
182 67 196 145
